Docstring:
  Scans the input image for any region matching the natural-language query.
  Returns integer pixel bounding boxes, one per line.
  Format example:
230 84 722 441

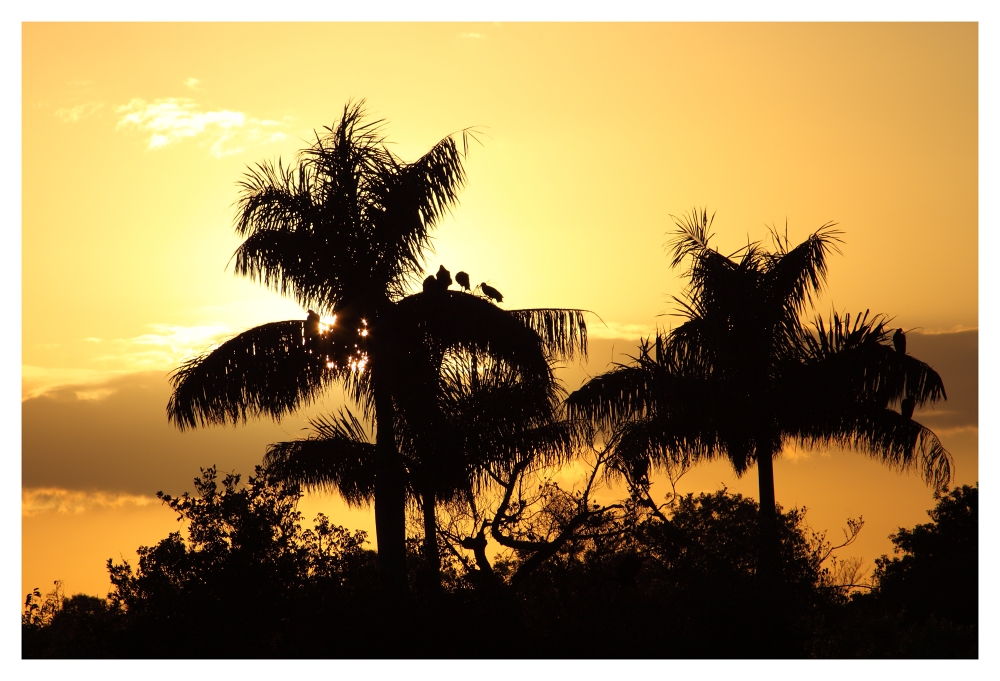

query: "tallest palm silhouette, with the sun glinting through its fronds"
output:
167 102 586 585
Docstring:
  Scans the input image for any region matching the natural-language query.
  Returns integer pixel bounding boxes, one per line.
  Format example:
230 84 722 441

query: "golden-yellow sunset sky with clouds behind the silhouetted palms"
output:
21 23 979 595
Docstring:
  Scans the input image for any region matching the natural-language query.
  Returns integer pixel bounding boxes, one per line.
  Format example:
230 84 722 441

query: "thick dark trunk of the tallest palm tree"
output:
372 362 406 590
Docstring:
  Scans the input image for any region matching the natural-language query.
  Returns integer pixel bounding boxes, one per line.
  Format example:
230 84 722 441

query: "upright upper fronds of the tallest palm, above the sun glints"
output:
234 100 474 312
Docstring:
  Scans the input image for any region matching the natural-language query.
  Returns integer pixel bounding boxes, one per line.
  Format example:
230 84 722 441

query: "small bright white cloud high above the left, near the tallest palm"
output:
116 97 285 157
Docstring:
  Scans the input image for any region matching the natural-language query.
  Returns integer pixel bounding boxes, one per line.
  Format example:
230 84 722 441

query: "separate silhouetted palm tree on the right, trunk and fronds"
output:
567 211 951 581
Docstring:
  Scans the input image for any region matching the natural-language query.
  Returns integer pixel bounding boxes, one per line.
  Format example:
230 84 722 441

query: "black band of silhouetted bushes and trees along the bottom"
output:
22 468 978 658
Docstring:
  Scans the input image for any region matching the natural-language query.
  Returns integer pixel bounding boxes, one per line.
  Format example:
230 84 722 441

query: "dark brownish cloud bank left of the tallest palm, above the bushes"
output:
21 371 343 494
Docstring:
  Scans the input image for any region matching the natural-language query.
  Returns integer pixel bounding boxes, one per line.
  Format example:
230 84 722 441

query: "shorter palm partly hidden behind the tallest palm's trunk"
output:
264 350 579 589
